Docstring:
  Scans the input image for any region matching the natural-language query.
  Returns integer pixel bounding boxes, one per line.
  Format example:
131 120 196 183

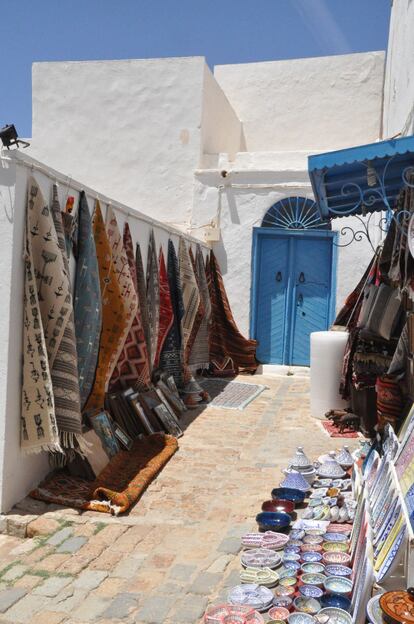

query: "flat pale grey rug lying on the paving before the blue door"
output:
200 379 268 410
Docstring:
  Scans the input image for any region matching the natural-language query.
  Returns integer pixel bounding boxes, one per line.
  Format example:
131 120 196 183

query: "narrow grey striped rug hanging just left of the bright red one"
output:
147 230 160 371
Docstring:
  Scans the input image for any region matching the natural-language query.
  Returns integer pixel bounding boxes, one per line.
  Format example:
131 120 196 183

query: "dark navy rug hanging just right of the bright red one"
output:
160 240 184 388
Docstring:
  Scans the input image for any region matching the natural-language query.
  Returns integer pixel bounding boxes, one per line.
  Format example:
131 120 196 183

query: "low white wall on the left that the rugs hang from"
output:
0 152 209 512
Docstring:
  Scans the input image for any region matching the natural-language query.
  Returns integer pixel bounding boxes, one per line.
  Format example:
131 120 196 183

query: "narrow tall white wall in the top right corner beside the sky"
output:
383 0 414 139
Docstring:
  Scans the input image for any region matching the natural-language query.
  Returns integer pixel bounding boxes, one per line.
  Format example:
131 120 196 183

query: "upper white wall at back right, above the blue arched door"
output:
214 52 384 152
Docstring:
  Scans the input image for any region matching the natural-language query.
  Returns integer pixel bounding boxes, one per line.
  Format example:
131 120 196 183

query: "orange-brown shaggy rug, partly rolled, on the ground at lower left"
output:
30 433 178 515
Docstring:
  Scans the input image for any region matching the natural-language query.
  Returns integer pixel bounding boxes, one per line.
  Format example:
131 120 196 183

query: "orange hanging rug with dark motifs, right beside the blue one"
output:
86 200 128 410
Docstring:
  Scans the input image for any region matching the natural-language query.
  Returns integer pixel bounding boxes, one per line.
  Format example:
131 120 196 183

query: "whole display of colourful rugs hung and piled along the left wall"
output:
21 177 257 513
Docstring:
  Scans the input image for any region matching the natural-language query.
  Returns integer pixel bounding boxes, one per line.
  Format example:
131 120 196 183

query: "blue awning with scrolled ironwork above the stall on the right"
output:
308 136 414 219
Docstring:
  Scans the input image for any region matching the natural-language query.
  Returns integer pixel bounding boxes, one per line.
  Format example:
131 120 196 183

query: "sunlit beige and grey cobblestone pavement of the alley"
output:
0 376 358 624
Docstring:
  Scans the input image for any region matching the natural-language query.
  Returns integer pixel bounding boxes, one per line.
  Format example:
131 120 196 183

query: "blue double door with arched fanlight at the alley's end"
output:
251 197 337 366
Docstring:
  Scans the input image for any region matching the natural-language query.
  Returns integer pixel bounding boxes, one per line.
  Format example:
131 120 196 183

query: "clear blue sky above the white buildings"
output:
0 0 391 137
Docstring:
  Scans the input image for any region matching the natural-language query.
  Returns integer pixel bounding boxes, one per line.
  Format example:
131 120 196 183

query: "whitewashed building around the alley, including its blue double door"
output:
0 0 414 509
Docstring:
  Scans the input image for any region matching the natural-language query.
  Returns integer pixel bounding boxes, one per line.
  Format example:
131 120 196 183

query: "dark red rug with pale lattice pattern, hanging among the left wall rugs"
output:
109 223 151 392
